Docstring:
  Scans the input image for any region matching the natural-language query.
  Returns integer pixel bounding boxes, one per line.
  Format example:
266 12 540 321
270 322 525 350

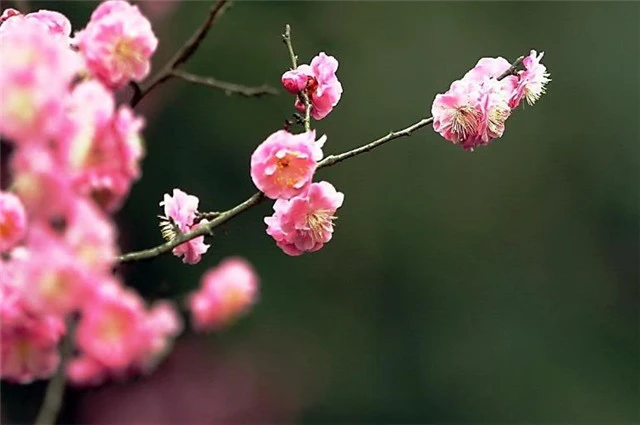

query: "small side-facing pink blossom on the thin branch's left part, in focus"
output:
160 189 209 264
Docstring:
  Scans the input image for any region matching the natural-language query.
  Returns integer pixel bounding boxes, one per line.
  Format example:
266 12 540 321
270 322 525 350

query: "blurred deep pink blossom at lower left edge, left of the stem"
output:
0 276 65 384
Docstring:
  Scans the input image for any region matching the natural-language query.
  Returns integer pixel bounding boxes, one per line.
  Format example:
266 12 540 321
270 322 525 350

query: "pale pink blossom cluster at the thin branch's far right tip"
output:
431 50 550 150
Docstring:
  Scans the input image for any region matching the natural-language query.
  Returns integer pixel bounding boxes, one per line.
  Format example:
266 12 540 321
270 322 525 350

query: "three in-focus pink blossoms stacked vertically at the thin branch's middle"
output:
245 52 344 256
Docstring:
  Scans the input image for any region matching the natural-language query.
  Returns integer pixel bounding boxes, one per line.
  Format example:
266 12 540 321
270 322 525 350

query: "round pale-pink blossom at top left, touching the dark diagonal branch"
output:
75 0 158 88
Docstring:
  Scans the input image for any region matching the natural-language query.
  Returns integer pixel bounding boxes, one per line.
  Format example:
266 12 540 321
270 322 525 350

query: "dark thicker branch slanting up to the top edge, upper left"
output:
129 0 230 107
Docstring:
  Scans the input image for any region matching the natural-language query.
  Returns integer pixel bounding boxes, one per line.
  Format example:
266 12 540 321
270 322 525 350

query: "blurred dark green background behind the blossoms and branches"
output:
2 1 640 424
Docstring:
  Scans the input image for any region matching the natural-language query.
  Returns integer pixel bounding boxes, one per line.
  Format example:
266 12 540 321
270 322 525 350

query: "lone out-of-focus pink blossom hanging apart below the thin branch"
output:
187 257 258 331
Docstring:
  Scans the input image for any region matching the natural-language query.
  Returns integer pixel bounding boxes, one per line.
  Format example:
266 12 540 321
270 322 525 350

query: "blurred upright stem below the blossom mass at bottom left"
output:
34 319 75 425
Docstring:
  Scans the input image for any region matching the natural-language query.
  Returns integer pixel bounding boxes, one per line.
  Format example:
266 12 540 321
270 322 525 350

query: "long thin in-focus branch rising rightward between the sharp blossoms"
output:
118 54 523 262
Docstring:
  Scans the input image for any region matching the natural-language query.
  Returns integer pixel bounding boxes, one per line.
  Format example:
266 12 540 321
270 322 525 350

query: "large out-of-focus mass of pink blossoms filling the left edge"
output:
0 0 182 384
